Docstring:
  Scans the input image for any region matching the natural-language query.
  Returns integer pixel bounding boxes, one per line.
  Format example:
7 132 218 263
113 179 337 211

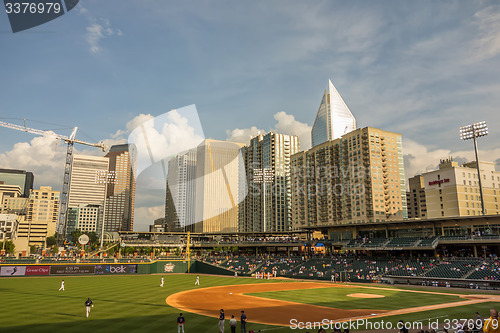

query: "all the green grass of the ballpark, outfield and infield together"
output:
0 274 500 333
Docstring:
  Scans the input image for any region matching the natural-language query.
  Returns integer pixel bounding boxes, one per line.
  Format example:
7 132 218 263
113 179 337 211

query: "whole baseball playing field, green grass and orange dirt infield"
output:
0 274 500 333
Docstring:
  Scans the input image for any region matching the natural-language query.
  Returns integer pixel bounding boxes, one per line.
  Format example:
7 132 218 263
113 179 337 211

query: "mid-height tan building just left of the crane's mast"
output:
17 186 60 248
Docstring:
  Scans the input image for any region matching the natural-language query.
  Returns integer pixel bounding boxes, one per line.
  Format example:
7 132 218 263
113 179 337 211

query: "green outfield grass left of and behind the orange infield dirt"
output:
0 274 289 333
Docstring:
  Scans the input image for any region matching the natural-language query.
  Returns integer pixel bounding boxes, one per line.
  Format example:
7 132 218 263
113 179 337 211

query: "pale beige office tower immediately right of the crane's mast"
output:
66 154 109 235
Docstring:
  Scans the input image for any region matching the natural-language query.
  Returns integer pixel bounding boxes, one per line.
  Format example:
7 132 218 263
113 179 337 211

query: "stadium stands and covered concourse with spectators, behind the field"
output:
0 216 500 289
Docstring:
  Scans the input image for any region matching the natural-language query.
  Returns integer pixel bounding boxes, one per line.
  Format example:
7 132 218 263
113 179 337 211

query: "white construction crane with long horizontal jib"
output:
0 119 106 245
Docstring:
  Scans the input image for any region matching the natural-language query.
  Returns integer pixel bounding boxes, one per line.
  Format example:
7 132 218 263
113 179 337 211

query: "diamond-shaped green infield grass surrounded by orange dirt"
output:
249 286 464 310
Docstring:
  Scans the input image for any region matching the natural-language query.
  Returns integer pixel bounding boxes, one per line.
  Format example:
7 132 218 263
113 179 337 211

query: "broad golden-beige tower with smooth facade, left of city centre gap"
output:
192 139 244 233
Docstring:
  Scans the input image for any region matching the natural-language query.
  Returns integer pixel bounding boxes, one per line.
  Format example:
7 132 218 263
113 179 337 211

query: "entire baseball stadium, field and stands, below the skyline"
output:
0 216 500 333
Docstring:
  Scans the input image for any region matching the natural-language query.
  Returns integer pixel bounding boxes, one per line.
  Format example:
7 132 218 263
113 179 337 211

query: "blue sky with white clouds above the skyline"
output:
0 0 500 228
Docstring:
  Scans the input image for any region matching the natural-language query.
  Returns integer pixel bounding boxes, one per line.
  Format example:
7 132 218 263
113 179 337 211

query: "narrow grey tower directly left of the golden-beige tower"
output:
165 148 197 231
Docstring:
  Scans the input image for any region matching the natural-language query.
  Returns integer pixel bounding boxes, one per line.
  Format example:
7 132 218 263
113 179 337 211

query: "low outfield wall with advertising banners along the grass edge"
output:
0 260 234 277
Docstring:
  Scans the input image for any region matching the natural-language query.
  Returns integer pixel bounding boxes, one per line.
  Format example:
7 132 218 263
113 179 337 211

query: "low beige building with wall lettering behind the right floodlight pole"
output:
423 159 500 218
